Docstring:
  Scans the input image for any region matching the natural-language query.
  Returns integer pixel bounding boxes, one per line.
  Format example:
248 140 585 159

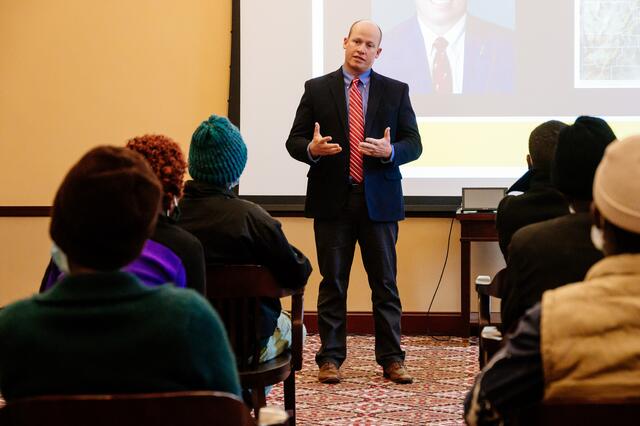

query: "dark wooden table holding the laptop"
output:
456 210 498 337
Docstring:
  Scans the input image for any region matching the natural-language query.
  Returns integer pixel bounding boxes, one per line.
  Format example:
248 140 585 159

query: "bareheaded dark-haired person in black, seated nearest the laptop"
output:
496 120 569 259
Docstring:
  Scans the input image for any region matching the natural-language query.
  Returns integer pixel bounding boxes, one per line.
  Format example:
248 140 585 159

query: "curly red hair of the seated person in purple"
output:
127 135 187 209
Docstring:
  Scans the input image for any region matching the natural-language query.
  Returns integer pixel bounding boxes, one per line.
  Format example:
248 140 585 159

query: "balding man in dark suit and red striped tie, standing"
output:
286 21 422 383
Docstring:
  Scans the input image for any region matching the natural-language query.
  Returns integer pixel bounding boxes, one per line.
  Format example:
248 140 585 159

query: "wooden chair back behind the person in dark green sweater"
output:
0 391 256 426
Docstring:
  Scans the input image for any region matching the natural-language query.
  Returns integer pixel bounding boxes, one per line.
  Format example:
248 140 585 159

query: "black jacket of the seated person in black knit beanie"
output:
501 213 602 330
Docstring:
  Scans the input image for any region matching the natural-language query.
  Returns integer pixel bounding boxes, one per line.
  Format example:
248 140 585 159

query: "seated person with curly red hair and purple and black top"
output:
40 135 205 294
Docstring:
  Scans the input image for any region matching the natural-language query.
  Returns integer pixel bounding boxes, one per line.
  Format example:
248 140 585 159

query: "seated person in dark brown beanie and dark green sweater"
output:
0 146 240 401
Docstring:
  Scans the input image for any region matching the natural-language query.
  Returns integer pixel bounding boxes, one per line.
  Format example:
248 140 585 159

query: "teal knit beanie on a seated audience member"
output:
189 115 247 186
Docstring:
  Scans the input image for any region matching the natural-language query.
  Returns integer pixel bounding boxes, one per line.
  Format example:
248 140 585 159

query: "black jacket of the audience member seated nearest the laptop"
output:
496 170 569 260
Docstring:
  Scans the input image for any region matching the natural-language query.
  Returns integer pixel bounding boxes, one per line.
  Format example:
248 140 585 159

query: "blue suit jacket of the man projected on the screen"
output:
376 15 514 95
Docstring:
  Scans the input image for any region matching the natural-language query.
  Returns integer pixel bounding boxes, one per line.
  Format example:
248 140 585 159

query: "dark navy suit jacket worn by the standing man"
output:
286 69 422 222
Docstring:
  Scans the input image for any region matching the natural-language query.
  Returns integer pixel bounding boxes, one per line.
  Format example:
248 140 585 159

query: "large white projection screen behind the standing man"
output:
240 0 640 200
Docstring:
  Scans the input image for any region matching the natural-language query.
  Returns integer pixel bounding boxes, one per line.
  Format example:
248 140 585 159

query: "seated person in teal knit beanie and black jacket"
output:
179 115 311 361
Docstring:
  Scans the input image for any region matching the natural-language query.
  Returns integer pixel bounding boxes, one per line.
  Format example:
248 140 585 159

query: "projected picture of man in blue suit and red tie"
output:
376 0 514 94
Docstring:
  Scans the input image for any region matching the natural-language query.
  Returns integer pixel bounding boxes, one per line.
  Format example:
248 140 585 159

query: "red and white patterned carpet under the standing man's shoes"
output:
267 335 478 426
